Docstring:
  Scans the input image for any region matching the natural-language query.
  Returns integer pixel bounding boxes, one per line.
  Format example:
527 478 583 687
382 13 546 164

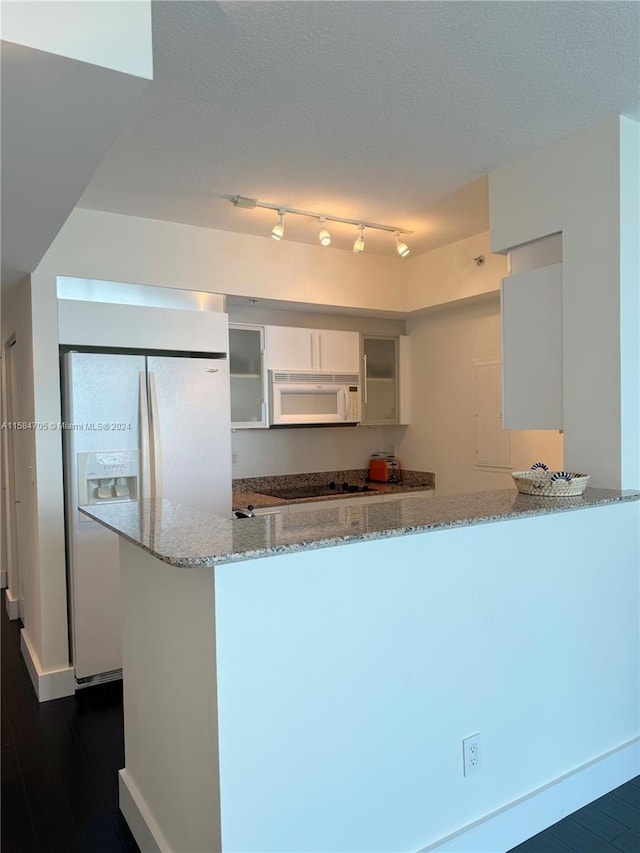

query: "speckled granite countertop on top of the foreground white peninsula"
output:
80 489 640 568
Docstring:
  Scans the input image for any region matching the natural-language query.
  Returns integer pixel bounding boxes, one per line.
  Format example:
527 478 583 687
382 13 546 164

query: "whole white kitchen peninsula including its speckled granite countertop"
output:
84 489 640 853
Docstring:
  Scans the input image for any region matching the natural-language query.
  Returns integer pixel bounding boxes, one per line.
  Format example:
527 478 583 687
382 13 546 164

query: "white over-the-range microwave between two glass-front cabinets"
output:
269 370 360 427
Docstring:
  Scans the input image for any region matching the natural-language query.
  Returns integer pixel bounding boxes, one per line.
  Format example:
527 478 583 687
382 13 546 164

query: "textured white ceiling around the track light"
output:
80 0 640 254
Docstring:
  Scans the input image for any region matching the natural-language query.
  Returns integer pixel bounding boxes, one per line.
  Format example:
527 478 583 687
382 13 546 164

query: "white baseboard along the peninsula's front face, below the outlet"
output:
419 738 640 853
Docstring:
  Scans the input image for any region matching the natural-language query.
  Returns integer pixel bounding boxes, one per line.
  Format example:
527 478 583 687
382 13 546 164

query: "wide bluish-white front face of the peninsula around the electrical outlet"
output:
212 502 640 853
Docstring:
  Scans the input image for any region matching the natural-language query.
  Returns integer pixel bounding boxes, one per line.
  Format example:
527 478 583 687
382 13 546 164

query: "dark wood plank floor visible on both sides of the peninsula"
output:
0 597 640 853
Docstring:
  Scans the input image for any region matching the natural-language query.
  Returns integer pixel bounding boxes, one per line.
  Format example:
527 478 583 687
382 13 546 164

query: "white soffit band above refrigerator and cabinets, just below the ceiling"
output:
43 208 506 322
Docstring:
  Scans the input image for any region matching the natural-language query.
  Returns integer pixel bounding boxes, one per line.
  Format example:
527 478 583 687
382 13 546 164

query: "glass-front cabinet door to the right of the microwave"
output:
362 335 399 424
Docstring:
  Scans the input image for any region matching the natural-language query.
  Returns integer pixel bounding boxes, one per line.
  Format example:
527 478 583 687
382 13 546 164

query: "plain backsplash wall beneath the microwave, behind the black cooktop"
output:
231 427 406 480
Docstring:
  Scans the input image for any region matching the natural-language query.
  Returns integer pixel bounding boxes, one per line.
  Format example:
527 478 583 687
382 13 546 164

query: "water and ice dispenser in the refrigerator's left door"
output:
78 450 138 506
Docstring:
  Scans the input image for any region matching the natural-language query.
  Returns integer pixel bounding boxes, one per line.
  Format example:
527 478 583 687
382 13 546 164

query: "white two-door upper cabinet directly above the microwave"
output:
267 326 360 373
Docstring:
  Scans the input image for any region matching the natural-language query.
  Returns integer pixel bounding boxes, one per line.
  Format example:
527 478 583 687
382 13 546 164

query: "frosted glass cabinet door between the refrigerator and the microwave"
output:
229 323 268 429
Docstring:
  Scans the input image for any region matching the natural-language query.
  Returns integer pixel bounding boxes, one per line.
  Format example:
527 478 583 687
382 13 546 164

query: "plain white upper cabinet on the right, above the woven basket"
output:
501 264 562 429
